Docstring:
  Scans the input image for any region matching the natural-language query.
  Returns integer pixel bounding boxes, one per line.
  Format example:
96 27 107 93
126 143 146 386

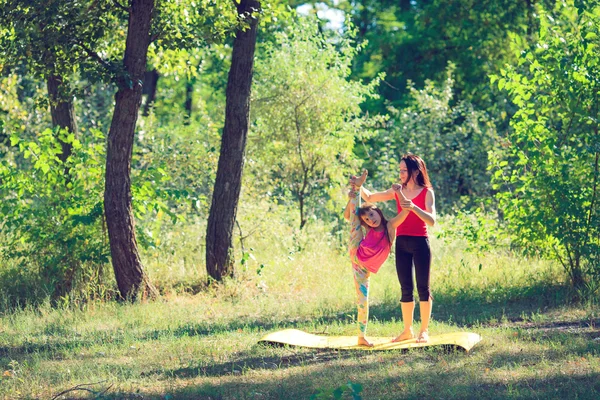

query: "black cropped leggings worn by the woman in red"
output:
396 236 433 303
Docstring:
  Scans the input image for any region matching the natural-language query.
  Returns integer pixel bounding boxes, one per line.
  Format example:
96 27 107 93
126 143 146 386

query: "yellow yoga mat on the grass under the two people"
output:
259 329 481 352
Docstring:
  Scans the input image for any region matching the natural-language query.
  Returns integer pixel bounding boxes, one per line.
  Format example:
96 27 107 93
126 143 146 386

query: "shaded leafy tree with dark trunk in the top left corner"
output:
0 0 113 162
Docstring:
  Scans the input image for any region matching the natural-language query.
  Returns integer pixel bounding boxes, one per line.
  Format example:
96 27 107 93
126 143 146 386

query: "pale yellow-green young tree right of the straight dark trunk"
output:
248 18 380 227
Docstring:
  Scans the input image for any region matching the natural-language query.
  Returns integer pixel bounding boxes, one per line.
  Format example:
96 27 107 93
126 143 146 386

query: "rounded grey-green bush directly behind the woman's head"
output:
369 65 496 213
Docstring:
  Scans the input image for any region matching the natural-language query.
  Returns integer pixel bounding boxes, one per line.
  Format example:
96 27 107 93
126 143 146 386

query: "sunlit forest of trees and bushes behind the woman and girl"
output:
0 0 600 398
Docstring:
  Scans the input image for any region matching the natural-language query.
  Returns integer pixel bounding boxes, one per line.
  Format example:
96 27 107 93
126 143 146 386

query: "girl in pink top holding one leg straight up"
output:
344 170 409 347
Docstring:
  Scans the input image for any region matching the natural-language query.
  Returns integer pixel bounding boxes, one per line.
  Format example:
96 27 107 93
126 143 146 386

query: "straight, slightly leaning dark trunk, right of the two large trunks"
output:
206 0 260 281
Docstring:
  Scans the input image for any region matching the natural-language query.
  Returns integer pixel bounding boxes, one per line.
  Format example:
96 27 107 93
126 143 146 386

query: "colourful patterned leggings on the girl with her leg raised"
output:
348 191 371 337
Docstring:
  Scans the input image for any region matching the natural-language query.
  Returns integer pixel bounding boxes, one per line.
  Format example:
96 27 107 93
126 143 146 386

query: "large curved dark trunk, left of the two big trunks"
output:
104 0 157 300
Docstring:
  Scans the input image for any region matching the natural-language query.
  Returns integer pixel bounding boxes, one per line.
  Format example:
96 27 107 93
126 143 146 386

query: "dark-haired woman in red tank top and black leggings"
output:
351 154 436 343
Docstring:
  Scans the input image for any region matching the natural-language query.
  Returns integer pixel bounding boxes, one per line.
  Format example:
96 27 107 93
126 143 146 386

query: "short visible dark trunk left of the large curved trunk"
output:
46 74 77 162
